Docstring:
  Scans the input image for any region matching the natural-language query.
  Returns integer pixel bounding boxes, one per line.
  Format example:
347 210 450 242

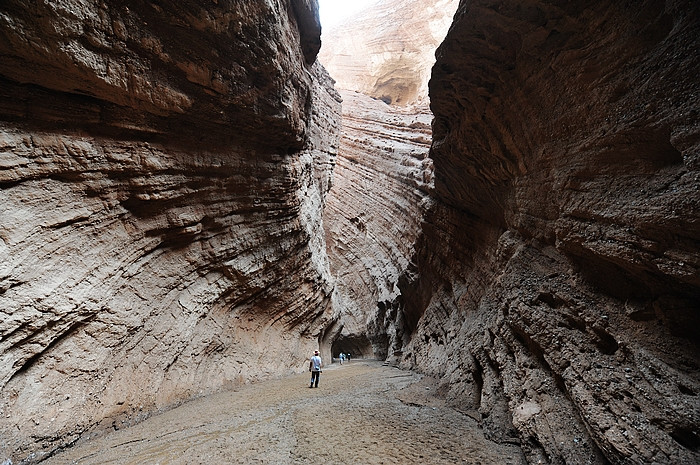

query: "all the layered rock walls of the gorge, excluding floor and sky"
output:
0 0 700 465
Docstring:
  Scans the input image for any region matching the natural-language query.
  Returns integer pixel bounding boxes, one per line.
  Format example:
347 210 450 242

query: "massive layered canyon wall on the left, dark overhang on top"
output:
0 0 340 463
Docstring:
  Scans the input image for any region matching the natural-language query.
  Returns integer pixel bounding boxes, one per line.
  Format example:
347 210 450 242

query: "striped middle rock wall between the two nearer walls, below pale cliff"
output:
324 91 432 359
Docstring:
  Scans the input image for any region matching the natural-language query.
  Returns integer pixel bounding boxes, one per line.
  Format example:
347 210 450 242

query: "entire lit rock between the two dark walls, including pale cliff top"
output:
319 0 458 359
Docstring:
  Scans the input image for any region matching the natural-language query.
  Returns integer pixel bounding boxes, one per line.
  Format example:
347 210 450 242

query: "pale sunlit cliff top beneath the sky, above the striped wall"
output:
319 0 458 105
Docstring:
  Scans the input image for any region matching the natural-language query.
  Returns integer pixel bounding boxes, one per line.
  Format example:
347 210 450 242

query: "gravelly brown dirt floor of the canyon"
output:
42 361 525 465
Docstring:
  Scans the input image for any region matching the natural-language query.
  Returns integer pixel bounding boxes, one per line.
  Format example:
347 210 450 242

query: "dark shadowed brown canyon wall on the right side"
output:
395 0 700 464
